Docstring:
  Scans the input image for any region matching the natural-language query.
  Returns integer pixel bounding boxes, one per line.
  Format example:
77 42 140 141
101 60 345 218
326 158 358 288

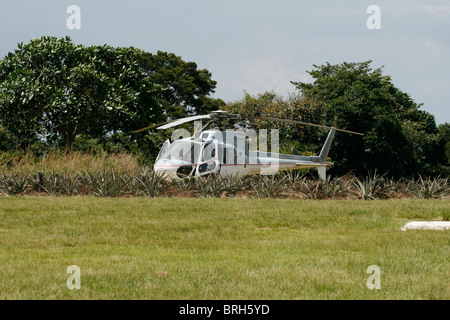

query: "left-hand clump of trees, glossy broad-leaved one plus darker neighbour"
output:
0 36 225 155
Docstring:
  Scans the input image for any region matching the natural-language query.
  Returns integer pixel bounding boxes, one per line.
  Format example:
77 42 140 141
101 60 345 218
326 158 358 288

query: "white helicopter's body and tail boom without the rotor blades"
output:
154 130 334 179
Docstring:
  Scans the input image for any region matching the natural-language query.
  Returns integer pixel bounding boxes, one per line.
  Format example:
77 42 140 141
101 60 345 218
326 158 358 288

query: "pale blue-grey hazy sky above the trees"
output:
0 0 450 124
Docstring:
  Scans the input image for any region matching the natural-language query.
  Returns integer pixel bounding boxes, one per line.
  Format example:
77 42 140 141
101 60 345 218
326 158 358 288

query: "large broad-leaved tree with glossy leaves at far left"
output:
0 37 165 151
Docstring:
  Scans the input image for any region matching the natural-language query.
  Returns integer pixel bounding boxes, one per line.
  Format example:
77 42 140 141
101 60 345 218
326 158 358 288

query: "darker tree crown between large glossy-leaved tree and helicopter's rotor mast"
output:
140 51 225 119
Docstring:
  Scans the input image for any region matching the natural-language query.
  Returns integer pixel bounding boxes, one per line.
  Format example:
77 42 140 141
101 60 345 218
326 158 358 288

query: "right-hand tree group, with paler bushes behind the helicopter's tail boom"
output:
225 61 450 177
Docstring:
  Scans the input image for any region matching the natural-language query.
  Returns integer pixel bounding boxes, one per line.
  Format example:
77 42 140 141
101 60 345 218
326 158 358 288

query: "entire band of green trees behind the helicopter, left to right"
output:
0 36 444 176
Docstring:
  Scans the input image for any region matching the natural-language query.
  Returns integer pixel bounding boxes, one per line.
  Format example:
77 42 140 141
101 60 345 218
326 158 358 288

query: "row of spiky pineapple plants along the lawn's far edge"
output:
0 168 450 200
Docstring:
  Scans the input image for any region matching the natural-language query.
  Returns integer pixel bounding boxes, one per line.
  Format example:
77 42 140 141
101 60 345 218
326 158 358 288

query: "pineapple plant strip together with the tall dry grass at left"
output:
0 151 450 200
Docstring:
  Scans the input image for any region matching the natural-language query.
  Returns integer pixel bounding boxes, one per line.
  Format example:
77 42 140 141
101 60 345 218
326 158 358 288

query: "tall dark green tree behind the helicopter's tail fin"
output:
292 61 438 176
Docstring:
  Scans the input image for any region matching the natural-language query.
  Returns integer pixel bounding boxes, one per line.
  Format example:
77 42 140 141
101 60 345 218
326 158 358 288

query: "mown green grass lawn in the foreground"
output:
0 197 450 299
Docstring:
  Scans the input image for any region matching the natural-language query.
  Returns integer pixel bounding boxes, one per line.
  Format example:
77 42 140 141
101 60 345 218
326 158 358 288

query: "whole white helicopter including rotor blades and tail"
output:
133 110 364 180
